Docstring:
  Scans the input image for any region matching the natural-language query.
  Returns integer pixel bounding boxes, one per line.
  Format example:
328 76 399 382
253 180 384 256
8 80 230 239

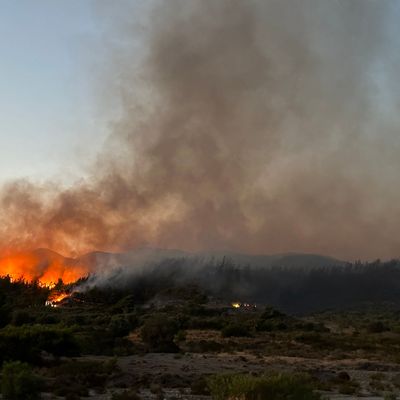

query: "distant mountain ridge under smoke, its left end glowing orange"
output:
0 247 345 282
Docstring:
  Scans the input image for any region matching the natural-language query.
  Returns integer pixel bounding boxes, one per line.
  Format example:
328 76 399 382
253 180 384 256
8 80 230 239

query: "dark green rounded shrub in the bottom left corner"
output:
1 361 42 400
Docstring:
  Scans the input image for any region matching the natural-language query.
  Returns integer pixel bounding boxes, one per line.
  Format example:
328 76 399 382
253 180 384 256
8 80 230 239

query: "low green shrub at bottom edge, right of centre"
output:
208 374 321 400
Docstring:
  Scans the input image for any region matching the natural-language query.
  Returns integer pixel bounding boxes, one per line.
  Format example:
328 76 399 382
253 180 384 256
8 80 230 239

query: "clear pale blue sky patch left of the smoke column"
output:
0 0 103 182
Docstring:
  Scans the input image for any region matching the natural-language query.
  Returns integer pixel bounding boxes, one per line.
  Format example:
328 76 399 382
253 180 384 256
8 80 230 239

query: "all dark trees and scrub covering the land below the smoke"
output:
0 262 400 400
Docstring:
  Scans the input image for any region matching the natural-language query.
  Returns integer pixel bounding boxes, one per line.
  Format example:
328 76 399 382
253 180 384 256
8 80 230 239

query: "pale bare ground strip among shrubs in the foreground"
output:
79 352 400 400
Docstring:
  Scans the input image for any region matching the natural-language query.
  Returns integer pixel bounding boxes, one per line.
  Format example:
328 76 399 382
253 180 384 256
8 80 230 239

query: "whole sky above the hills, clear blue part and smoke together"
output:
0 0 400 259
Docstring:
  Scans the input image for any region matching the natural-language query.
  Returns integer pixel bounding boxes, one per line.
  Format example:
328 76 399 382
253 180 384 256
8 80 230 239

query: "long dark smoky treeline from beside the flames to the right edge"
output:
79 259 400 313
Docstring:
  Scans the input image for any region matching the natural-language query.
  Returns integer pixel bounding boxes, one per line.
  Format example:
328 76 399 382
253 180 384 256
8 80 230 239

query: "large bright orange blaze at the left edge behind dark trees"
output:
0 249 89 287
